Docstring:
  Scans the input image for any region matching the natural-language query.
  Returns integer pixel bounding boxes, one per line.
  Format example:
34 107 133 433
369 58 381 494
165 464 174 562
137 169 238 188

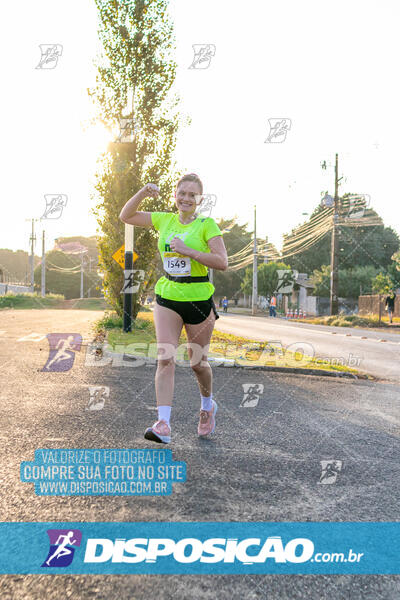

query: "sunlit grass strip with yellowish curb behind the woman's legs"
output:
95 311 357 374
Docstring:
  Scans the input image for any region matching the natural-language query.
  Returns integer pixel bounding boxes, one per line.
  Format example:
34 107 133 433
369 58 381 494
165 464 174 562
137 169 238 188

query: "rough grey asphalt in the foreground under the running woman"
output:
0 310 400 600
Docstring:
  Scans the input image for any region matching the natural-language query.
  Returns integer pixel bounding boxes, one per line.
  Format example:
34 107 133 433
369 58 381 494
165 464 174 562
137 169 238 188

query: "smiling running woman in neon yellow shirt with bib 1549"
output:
120 173 228 444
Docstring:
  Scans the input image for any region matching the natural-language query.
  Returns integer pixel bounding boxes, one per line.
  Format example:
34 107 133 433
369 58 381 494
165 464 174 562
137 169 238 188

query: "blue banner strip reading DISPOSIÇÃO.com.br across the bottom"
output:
0 522 400 575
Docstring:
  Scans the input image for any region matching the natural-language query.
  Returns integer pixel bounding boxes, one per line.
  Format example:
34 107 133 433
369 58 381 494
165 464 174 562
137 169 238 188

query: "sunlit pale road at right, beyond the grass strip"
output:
216 312 400 382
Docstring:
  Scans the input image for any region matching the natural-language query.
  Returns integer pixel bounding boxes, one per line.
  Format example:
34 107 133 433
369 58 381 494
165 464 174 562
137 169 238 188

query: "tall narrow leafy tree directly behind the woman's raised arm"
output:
88 0 179 318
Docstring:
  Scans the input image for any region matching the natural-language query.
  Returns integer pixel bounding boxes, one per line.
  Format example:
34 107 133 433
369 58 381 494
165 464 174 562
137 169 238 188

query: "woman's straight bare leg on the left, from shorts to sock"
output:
153 303 183 406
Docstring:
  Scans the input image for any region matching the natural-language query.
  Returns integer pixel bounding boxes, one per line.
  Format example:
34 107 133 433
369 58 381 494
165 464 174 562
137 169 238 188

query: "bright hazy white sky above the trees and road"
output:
0 0 400 262
